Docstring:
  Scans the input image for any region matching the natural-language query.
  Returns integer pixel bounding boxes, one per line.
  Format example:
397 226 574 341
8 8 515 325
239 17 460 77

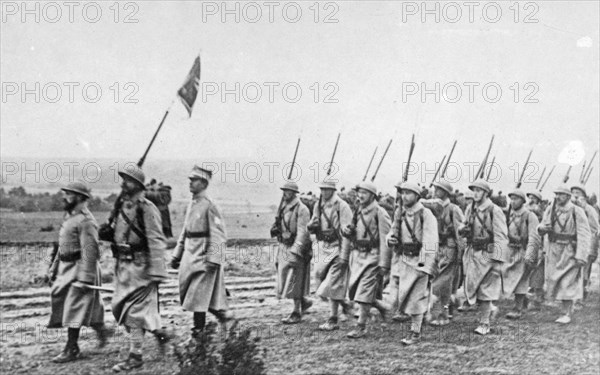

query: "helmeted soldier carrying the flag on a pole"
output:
106 166 169 372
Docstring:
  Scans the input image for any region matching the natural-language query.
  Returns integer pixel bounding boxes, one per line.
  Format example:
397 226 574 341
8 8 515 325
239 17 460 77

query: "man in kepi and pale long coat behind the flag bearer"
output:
170 166 236 339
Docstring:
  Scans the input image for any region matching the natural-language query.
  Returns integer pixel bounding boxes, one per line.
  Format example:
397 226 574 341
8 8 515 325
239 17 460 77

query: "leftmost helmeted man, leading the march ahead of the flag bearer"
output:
48 182 106 363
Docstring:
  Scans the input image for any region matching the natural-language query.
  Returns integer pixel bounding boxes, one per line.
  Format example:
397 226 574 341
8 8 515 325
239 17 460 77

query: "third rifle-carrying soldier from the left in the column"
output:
342 182 391 338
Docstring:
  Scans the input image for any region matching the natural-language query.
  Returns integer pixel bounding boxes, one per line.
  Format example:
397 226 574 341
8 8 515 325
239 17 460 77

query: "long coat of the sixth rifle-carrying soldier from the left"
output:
461 199 509 304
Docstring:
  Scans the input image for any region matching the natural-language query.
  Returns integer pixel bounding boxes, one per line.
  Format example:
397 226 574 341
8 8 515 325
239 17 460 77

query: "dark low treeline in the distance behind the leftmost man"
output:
0 186 117 212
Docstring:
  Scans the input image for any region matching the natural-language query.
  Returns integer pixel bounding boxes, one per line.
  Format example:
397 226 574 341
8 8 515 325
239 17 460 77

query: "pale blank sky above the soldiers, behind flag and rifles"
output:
0 1 600 190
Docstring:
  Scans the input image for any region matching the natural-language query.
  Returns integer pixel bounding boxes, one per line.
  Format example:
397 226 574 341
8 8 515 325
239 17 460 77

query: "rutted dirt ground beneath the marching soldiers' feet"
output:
0 213 600 375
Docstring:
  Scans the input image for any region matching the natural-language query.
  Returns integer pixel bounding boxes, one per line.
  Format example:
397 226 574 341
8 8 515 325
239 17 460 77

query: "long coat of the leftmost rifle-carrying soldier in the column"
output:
277 198 311 299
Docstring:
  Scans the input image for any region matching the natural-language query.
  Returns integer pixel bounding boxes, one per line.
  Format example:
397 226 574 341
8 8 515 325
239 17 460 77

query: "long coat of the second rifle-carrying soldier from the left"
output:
311 194 352 300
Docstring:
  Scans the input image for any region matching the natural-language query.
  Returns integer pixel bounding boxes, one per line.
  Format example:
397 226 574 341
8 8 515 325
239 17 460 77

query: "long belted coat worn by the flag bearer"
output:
112 192 167 331
